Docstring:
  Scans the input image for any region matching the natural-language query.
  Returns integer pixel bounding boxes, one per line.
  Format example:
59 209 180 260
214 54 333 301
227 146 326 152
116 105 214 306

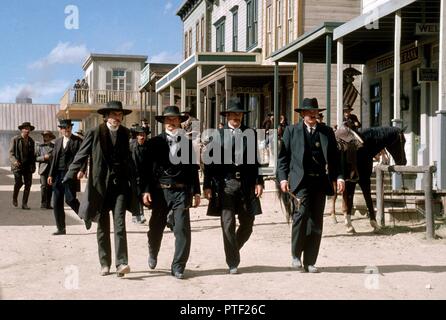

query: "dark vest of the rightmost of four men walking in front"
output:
303 126 326 174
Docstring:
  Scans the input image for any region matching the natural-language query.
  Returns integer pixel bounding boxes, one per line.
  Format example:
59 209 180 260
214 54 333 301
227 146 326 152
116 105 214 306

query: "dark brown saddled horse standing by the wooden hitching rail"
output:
331 127 407 233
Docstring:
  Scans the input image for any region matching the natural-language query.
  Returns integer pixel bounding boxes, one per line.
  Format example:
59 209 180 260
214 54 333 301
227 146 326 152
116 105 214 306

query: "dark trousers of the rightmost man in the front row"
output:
291 176 327 266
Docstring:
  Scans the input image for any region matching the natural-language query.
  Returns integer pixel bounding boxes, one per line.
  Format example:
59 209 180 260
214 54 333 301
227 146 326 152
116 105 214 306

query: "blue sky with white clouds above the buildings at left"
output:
0 0 182 103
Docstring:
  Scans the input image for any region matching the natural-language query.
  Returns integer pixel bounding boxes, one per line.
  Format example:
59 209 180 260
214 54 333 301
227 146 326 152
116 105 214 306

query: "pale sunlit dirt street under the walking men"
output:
0 168 446 300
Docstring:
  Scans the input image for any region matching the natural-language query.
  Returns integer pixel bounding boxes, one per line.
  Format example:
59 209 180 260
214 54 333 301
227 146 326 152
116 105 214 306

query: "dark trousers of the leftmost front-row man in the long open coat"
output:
97 186 128 267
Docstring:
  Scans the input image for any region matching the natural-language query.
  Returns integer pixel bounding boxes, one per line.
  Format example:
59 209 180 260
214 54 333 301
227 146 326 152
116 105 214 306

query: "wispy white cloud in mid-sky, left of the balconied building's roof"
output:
29 42 89 69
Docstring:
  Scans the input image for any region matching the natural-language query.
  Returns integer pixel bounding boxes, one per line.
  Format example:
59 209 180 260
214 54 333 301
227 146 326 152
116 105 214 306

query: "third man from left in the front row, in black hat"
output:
203 98 264 274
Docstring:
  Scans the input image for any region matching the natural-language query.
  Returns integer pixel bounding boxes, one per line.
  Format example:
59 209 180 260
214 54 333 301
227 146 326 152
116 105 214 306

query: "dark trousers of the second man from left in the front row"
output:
147 189 191 274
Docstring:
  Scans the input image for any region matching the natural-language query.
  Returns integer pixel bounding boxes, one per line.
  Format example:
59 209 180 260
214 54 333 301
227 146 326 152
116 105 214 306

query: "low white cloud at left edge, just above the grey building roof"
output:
0 80 70 103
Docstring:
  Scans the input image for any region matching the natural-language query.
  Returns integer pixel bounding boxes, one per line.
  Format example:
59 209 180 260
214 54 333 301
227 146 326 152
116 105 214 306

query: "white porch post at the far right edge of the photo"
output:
435 0 446 190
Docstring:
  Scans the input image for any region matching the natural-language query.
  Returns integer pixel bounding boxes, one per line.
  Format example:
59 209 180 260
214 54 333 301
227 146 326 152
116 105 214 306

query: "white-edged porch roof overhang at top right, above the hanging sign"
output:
332 0 440 64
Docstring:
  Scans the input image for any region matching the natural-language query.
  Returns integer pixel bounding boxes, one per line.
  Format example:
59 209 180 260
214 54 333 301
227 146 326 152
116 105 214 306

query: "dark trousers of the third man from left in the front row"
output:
220 179 255 268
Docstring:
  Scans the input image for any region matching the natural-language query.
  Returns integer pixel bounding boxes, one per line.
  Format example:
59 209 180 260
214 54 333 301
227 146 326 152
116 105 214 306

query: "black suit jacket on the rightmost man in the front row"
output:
277 121 343 195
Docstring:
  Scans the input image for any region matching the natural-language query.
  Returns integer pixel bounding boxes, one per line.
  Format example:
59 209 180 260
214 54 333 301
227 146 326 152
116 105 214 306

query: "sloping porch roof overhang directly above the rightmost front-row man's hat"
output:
271 22 342 63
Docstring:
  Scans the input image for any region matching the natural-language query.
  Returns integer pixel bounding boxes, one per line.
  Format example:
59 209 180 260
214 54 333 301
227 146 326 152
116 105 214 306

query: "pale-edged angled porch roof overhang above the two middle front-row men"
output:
156 52 261 92
